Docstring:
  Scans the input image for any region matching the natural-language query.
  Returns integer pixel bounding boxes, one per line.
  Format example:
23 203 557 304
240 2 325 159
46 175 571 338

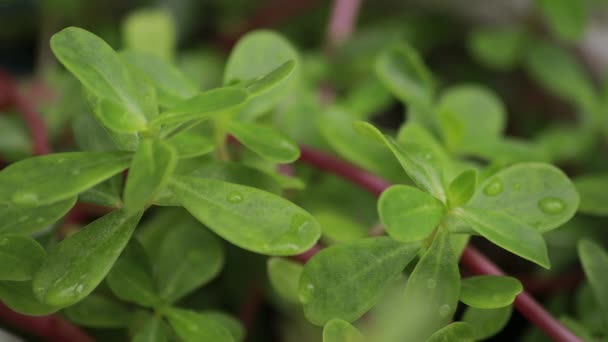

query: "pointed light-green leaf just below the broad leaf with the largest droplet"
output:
454 207 551 269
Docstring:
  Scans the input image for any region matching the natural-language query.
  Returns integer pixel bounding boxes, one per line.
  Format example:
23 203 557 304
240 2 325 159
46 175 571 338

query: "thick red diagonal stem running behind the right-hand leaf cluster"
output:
296 146 580 342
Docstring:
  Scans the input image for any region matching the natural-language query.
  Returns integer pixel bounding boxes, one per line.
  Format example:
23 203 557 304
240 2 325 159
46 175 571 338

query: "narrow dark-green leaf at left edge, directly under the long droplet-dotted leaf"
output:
0 198 76 236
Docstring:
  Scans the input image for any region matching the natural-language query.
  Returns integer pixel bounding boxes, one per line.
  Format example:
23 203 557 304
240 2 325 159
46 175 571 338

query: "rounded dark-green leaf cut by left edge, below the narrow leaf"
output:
0 235 46 281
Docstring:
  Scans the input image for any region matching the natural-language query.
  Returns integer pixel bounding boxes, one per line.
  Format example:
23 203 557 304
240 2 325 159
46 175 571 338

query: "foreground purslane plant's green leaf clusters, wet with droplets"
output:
0 10 579 342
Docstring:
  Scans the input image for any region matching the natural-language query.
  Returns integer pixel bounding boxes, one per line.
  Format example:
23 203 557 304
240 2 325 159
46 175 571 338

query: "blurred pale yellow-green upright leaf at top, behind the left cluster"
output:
122 9 177 61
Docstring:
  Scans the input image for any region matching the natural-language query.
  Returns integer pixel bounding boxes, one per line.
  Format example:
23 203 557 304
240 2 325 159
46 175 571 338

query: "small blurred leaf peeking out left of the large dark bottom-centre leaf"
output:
266 257 304 304
